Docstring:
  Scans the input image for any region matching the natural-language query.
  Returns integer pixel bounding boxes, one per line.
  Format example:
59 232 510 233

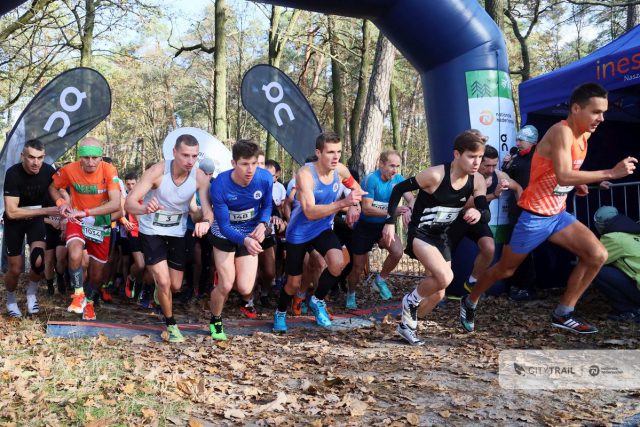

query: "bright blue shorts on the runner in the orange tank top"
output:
509 211 576 254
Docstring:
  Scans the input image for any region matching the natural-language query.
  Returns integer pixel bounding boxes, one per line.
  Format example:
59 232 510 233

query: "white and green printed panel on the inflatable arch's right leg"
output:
466 70 516 243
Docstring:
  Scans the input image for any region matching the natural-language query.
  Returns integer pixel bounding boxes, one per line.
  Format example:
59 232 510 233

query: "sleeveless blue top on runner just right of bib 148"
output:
286 163 340 244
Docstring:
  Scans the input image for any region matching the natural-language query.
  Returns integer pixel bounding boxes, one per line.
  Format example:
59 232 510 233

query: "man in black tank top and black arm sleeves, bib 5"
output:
382 130 491 345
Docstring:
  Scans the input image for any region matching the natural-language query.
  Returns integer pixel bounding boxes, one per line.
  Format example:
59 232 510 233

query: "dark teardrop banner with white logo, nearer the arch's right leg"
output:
241 64 322 165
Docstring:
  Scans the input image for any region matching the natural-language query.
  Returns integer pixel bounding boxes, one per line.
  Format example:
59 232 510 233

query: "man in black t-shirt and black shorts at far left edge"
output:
4 139 58 318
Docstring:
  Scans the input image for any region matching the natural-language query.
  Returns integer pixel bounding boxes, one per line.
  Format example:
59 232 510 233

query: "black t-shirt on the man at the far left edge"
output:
4 163 55 221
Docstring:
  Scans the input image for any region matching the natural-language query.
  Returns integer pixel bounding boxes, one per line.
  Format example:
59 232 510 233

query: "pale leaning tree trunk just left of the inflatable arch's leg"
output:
352 34 396 176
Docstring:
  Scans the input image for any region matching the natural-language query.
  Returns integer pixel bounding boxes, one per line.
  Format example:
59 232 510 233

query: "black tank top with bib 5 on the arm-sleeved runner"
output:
409 164 473 235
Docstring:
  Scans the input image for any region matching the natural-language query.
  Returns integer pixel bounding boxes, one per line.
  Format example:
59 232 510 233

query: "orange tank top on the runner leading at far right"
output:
518 120 587 216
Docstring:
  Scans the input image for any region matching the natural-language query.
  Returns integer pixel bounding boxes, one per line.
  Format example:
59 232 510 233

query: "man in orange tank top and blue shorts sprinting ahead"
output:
460 83 637 334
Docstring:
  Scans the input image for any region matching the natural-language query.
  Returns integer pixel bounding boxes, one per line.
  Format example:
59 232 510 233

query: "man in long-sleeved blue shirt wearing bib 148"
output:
209 139 273 341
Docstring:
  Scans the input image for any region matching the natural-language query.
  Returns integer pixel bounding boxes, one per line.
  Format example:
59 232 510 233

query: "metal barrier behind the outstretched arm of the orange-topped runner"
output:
573 181 640 228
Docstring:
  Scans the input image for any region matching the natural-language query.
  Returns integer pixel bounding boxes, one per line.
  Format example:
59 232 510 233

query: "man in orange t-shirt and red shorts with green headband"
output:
49 137 121 320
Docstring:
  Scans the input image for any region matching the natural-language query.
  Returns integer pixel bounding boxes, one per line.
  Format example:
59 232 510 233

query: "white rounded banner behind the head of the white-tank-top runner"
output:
162 127 232 178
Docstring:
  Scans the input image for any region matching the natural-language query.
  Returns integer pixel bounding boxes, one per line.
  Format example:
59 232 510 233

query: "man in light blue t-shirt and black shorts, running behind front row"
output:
345 150 413 310
